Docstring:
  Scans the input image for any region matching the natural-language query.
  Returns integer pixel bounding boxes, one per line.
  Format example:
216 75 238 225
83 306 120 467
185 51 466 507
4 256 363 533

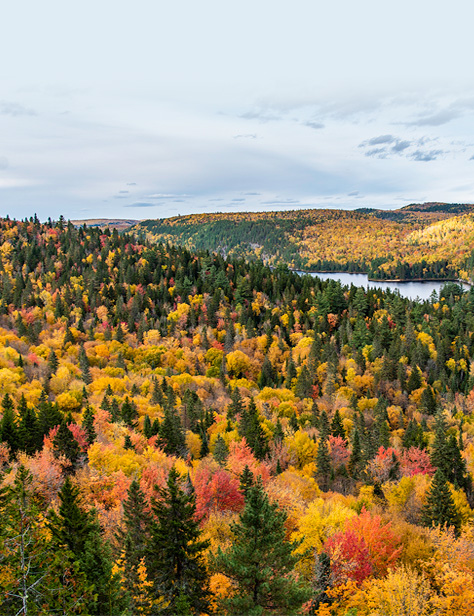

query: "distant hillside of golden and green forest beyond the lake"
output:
135 203 474 280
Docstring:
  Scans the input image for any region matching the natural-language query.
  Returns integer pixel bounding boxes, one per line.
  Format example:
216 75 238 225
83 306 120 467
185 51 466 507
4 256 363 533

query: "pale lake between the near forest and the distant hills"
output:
298 272 469 300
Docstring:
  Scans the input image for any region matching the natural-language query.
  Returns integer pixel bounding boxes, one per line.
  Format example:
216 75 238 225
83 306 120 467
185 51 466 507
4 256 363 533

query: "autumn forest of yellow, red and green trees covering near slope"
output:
0 213 474 616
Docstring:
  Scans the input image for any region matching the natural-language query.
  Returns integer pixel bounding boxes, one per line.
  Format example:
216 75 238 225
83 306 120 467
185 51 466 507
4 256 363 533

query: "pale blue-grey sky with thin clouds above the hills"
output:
0 0 474 220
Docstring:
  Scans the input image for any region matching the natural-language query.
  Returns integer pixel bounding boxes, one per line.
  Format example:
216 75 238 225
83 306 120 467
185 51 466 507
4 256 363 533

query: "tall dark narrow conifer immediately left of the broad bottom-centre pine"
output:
147 467 210 616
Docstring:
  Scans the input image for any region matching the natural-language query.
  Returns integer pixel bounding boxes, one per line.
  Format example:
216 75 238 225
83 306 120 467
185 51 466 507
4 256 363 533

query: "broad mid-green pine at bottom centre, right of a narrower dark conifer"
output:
213 478 307 614
